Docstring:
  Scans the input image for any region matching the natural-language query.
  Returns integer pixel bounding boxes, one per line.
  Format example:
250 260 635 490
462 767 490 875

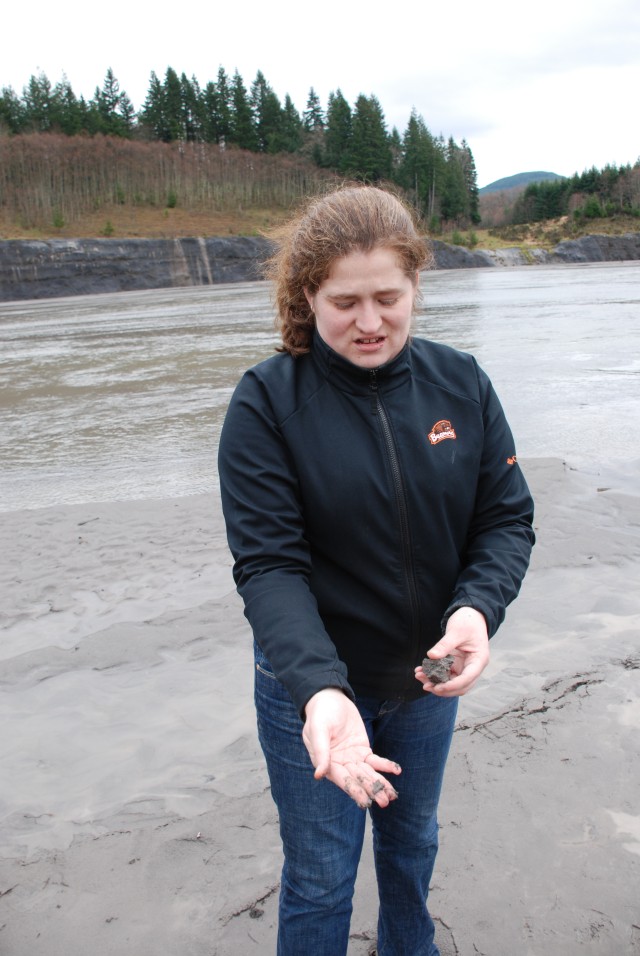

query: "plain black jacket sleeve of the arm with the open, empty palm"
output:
218 370 354 714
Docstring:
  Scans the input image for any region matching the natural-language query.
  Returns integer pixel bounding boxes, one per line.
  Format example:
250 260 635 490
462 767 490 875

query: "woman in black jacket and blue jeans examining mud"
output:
219 186 533 956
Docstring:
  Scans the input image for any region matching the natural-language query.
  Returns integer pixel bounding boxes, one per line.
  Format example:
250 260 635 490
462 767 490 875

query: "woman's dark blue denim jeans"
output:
255 645 457 956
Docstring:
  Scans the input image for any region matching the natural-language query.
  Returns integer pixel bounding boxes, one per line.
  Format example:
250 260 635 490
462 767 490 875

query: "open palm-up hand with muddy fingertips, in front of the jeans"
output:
302 687 401 810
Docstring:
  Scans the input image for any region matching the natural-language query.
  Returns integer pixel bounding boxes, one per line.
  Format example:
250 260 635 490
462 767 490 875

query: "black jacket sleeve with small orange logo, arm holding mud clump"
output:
443 365 535 637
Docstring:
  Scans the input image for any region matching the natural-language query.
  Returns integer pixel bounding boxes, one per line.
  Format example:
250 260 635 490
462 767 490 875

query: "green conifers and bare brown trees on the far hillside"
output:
0 67 640 234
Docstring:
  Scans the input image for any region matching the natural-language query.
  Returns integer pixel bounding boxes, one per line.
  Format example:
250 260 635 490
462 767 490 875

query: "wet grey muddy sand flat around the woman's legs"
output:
0 460 640 956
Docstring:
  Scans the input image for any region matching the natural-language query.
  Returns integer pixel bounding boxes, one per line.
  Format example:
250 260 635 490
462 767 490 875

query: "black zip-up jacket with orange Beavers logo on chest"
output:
219 335 534 712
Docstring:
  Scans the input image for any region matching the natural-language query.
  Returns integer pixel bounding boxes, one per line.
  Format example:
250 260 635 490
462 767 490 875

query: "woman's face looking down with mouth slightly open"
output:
305 248 418 368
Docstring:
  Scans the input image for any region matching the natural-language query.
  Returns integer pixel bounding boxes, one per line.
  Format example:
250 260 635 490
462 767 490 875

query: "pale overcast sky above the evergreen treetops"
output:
6 0 640 186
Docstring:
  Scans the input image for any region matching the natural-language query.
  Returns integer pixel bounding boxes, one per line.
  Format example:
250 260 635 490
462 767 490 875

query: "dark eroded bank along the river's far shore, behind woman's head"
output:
0 233 640 302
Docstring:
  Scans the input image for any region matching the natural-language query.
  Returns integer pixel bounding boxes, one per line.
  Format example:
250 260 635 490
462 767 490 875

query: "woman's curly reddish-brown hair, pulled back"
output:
264 184 432 357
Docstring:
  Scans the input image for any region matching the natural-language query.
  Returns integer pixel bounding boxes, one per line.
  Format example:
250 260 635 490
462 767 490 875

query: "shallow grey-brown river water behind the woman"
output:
0 262 640 511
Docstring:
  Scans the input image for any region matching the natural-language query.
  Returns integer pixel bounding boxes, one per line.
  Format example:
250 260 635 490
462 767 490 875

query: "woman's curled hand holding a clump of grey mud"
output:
415 607 489 697
